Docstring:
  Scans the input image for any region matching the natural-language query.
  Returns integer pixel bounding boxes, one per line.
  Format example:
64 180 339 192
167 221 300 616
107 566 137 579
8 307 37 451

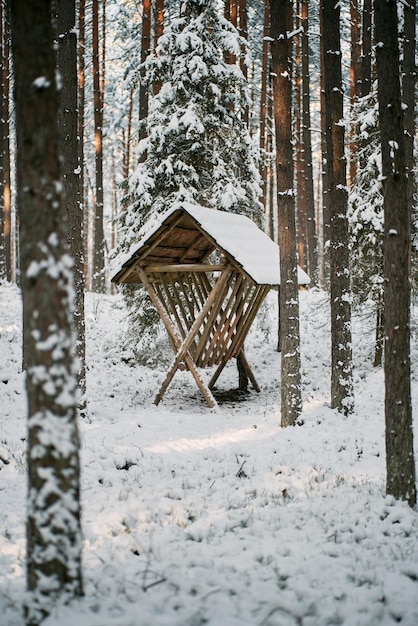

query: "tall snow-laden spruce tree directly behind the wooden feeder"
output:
114 0 262 364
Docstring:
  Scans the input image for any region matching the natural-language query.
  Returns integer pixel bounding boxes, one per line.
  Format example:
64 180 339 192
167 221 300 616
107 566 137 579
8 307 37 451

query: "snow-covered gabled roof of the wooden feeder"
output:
111 203 310 286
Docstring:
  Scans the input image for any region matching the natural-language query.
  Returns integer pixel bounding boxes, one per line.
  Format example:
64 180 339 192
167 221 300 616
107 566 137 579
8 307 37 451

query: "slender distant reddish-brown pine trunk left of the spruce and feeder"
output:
92 0 106 293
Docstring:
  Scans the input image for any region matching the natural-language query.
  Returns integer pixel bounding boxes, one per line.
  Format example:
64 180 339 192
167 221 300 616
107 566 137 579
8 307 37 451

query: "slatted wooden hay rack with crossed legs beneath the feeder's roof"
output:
136 261 269 408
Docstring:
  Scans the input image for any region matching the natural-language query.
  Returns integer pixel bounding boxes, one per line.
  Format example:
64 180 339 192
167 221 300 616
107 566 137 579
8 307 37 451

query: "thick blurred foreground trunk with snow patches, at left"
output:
11 0 82 626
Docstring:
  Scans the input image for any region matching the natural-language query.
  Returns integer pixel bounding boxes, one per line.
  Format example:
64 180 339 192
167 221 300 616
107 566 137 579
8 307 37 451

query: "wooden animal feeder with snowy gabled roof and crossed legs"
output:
112 203 309 407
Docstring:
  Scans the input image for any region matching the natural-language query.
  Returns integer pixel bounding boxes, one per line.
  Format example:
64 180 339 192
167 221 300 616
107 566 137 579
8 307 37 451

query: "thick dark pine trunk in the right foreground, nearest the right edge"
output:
375 0 416 506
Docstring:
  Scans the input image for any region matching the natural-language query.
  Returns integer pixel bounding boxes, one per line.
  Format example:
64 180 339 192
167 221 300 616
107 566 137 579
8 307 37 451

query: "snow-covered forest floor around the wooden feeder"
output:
0 285 418 626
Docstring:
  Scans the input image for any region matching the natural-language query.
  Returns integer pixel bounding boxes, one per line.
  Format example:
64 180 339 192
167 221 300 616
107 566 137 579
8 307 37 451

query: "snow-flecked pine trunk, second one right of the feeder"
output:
321 0 353 414
